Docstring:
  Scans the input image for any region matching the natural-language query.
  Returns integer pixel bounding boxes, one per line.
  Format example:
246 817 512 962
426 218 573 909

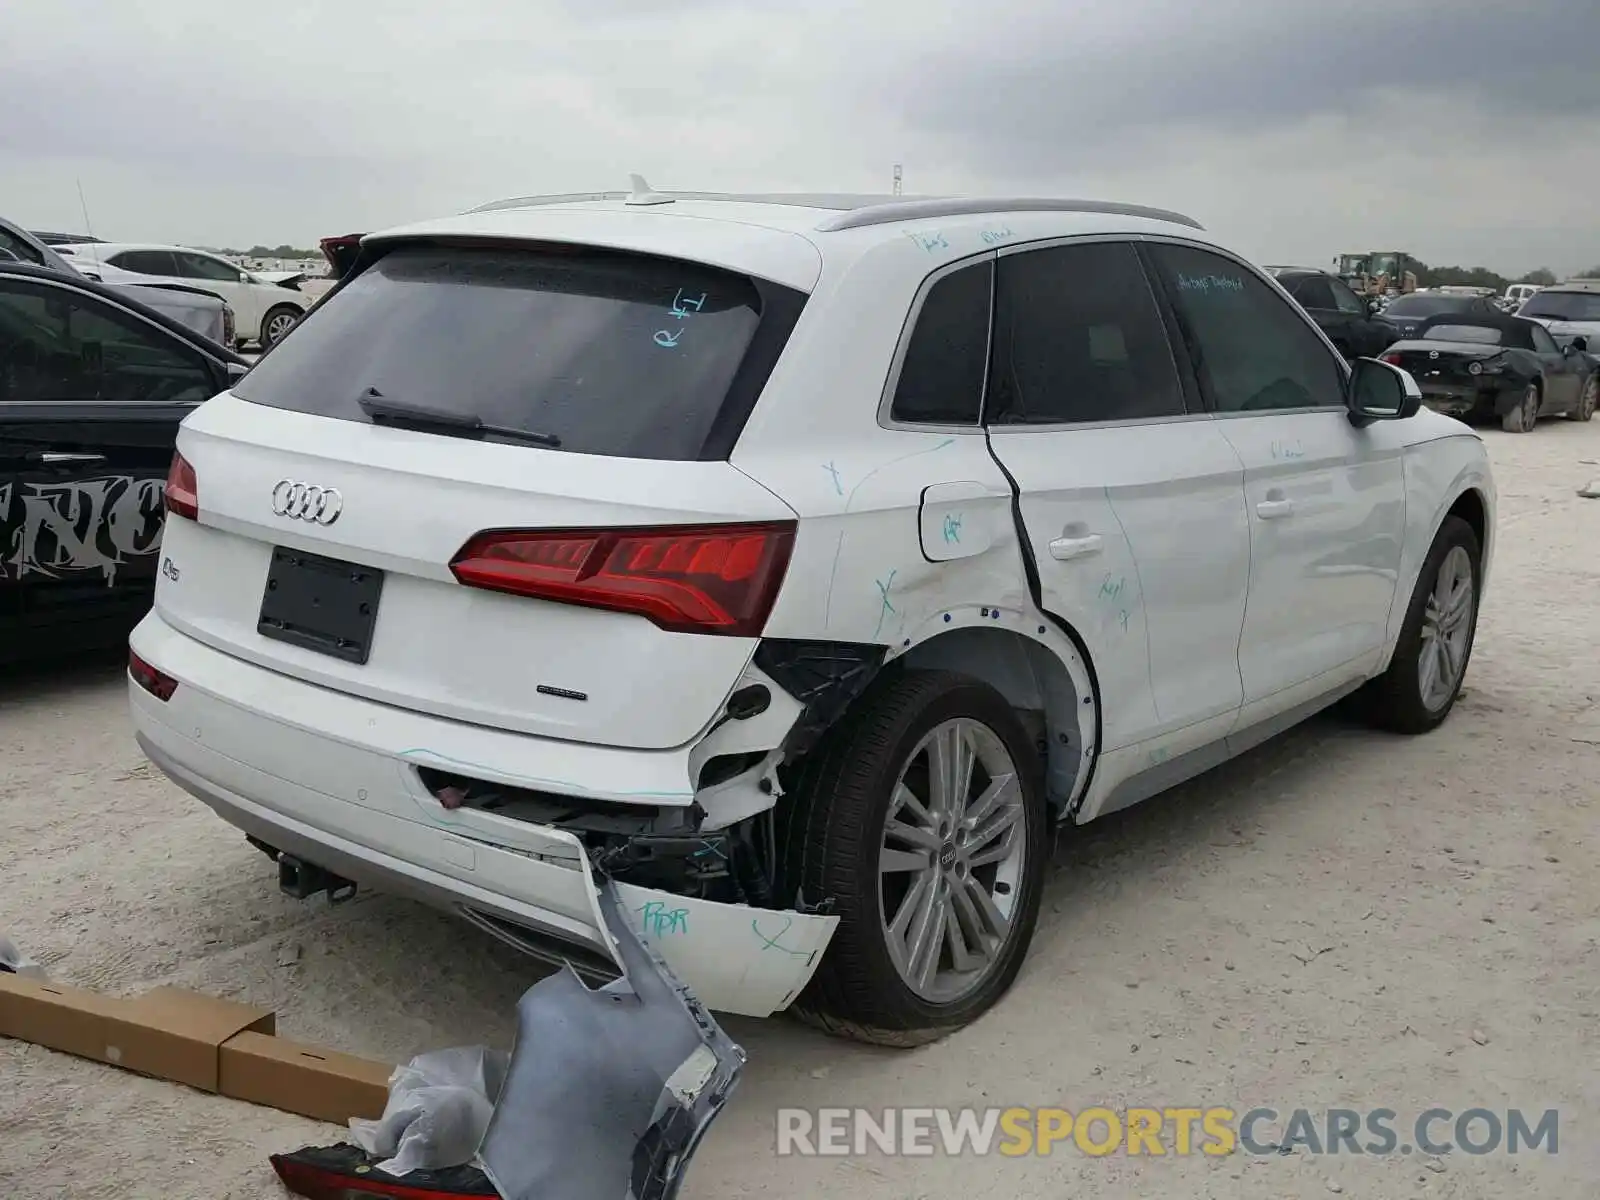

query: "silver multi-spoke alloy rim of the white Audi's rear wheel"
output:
878 717 1037 1005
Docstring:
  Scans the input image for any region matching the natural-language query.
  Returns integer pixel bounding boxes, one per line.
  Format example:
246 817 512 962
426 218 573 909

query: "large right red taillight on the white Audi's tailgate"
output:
450 522 795 637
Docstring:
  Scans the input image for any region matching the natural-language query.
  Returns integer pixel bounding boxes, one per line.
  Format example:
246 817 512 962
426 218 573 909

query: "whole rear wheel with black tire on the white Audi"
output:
781 667 1050 1048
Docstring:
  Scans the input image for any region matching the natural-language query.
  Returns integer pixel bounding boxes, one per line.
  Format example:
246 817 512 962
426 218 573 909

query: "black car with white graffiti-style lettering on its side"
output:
0 262 248 662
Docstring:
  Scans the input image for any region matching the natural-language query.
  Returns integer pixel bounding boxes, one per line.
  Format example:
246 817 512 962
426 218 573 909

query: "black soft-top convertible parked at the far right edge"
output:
1382 312 1600 434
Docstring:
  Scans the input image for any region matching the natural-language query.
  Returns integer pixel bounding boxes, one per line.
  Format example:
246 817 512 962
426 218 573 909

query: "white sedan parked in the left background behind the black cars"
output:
56 242 310 349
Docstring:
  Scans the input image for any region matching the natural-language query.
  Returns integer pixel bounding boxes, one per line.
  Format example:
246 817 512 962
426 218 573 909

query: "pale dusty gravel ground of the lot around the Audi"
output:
0 421 1600 1200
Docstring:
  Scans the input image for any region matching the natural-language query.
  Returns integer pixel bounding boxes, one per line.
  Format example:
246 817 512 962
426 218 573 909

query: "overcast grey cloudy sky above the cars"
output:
0 0 1600 274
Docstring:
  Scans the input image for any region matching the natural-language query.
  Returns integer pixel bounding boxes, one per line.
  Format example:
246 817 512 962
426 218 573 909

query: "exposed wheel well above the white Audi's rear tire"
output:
898 629 1098 814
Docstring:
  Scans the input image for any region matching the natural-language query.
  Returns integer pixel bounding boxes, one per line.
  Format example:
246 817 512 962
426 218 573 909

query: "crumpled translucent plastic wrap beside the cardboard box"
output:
350 1046 509 1174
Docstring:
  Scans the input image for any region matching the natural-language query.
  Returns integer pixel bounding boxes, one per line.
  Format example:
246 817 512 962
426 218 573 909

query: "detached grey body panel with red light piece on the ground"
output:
272 883 744 1200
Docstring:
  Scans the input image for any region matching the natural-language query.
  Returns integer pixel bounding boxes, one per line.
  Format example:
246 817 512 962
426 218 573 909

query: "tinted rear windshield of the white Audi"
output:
234 245 803 459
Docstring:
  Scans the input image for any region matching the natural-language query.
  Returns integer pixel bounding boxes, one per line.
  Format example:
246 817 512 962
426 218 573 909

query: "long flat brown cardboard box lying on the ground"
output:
0 973 394 1125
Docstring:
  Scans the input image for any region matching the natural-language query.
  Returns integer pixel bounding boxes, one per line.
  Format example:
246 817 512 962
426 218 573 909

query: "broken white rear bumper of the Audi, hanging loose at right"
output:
130 614 838 1016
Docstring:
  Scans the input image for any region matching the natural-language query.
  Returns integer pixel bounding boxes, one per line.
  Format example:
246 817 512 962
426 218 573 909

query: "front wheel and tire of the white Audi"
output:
1362 517 1483 734
